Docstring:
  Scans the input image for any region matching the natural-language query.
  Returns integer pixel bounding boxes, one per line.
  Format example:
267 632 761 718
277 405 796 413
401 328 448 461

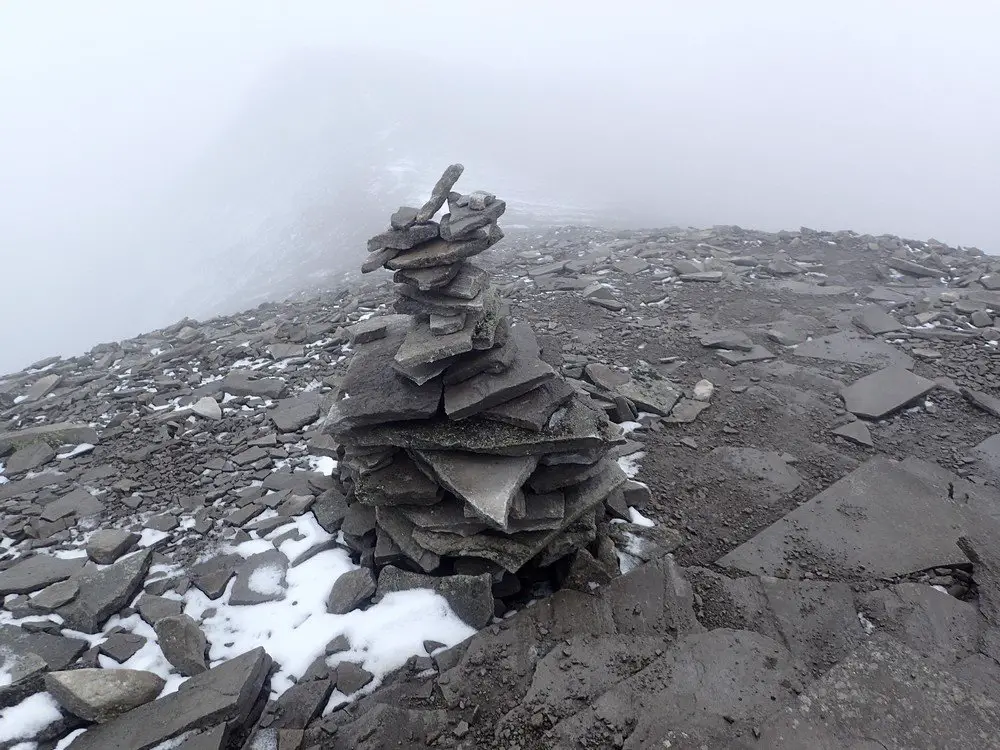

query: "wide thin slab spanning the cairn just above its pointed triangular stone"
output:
334 400 622 456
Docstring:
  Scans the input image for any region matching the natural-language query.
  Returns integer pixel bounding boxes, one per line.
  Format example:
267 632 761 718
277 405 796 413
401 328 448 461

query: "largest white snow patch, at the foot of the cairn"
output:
182 513 475 706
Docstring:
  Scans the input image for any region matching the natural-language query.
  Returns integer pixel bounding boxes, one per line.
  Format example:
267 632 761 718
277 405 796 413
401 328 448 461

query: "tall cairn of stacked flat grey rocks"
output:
324 165 626 580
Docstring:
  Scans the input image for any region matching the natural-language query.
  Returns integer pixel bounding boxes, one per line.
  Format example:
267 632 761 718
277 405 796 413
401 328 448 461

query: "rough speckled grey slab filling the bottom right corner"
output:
757 637 1000 750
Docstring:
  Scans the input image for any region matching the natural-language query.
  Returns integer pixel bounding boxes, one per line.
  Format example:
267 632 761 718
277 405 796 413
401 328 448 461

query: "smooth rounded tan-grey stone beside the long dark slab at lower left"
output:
45 669 166 723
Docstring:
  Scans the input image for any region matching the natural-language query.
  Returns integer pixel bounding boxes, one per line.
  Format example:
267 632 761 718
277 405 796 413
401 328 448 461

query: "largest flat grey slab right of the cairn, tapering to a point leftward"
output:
718 457 984 578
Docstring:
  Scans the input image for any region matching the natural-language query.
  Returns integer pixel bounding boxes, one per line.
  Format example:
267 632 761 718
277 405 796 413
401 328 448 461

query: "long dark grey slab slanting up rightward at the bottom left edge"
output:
67 648 271 750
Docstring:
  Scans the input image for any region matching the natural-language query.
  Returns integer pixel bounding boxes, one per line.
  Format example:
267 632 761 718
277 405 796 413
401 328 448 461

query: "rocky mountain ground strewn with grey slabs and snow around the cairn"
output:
0 220 1000 750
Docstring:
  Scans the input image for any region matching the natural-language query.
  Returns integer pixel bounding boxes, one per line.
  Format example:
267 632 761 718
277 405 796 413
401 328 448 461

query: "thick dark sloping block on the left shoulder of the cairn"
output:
327 317 442 426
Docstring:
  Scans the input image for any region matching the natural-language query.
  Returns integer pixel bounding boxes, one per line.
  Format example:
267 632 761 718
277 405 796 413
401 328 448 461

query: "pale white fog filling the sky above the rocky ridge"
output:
0 0 1000 373
